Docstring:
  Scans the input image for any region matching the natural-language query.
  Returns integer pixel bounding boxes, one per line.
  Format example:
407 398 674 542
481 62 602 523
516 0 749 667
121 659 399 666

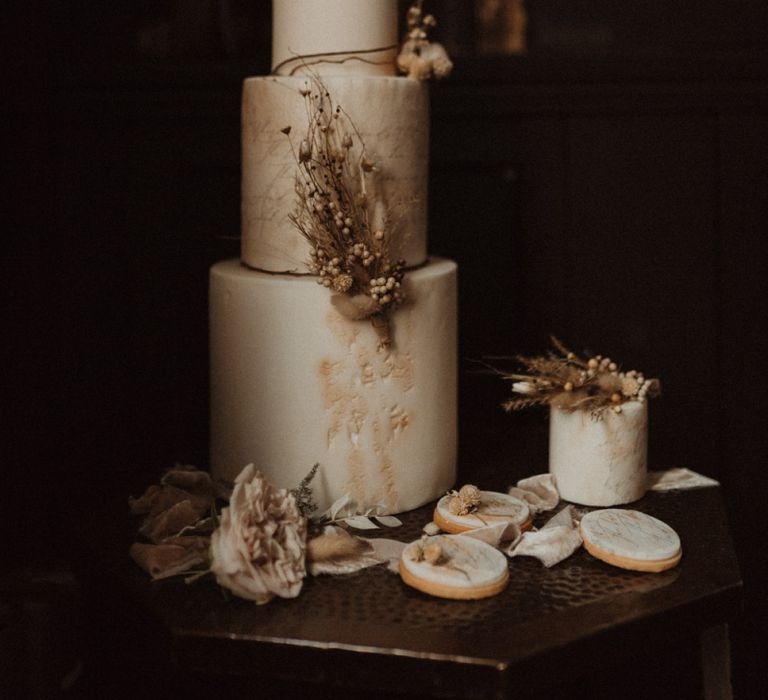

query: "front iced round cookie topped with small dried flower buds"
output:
400 535 509 600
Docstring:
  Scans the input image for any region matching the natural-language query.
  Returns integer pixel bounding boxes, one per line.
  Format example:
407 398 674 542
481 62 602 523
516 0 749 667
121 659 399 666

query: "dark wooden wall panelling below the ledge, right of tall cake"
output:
430 60 768 697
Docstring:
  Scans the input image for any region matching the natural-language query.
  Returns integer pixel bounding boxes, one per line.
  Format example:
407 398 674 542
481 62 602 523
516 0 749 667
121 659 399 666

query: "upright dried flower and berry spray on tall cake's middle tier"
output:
283 77 405 347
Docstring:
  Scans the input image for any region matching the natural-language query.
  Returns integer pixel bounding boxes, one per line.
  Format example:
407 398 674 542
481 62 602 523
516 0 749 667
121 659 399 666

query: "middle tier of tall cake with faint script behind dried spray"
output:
241 76 429 272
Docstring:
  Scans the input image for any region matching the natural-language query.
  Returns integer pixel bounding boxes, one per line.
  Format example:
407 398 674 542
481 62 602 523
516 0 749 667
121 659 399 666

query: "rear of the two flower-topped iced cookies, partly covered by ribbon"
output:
432 487 533 534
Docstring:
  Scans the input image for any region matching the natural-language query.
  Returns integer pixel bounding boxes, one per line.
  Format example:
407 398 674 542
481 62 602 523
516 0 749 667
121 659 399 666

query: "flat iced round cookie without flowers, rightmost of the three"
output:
579 508 683 572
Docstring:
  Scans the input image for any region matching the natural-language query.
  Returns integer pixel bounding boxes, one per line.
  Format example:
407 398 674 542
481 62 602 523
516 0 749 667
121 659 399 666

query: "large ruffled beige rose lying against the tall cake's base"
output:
211 464 307 605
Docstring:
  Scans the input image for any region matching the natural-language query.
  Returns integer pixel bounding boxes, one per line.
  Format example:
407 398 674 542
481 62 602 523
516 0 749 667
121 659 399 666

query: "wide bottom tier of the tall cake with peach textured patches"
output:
210 259 457 514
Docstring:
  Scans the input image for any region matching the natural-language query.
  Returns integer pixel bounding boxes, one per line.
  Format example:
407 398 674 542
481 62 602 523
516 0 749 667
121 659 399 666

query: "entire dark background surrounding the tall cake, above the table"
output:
6 0 768 697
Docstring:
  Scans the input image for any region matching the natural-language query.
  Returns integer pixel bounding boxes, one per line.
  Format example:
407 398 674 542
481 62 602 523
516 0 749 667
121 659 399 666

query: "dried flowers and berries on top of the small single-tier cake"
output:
499 336 661 418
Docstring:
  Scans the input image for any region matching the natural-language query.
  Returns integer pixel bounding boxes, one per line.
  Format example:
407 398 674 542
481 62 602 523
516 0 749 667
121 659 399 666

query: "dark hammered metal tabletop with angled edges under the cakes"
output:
85 488 741 697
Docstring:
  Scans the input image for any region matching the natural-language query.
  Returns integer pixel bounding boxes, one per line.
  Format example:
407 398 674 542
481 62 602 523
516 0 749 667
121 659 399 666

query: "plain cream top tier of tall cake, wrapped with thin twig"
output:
272 0 398 76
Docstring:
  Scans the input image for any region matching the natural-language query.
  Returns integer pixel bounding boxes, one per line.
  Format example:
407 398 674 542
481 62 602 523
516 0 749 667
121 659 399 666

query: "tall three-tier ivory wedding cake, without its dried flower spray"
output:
210 0 457 513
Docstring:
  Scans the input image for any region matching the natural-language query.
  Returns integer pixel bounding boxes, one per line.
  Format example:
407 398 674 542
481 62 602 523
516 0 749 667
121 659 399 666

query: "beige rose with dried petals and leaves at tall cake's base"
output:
129 464 402 605
